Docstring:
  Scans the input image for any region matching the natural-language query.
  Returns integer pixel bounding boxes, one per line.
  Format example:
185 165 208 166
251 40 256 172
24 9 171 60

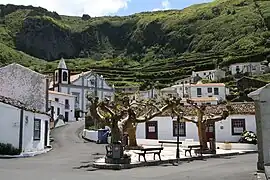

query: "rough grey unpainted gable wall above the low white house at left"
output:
0 64 47 112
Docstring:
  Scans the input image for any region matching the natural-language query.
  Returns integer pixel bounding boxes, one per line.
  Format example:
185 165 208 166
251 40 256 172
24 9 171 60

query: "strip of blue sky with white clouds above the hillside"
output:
0 0 212 16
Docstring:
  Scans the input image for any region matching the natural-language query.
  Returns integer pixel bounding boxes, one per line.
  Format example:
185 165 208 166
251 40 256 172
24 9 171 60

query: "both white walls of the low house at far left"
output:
0 103 50 152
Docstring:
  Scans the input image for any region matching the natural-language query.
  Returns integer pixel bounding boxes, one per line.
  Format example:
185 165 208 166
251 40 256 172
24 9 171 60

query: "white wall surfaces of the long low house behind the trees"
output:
136 115 256 142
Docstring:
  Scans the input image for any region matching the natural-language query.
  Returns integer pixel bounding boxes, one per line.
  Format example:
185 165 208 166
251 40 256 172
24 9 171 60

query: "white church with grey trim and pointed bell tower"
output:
50 58 115 117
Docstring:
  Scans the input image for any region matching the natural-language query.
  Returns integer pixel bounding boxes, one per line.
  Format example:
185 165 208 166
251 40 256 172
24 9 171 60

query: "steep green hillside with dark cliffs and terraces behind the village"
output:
0 0 270 88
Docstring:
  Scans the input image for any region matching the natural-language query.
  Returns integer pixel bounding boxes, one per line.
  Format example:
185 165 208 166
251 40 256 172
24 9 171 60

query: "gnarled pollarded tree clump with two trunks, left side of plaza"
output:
85 92 180 147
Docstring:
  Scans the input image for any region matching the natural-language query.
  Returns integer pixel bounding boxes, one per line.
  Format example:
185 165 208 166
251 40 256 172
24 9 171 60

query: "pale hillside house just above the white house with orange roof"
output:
191 69 225 81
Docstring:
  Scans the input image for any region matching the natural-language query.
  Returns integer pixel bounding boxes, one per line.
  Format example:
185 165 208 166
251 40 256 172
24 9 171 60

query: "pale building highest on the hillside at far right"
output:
229 62 266 75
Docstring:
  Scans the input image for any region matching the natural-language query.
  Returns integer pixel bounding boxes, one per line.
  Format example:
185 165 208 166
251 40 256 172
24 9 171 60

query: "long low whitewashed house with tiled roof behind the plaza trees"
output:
136 103 256 142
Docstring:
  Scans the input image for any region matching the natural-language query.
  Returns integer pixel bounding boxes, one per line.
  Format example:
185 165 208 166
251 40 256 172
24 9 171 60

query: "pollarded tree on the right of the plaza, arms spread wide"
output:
173 100 229 150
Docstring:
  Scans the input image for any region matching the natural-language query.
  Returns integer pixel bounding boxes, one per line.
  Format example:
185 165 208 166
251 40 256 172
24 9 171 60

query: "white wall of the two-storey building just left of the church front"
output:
49 91 75 121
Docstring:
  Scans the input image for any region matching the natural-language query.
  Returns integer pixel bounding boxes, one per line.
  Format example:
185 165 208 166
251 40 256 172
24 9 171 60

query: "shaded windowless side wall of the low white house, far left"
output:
0 103 21 148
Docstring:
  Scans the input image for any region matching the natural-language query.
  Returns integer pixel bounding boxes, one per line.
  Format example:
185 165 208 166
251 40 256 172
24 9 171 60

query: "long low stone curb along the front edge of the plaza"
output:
93 151 258 170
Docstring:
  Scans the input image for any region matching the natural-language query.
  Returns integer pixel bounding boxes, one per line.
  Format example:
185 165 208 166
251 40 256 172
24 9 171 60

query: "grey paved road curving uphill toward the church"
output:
0 122 262 180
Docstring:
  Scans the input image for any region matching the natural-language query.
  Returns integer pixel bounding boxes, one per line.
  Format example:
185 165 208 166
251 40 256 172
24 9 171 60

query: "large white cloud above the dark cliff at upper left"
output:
0 0 131 16
